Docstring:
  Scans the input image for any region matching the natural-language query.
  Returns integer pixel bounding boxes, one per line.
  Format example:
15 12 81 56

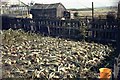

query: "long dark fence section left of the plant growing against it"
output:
2 17 81 39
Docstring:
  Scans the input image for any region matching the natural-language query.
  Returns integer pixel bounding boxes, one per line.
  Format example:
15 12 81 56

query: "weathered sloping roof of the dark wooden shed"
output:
31 3 63 9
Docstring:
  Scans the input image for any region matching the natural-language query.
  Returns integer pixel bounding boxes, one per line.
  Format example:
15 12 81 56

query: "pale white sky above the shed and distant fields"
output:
2 0 120 8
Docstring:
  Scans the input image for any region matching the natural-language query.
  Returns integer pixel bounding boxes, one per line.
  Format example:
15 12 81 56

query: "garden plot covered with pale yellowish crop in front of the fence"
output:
1 29 113 79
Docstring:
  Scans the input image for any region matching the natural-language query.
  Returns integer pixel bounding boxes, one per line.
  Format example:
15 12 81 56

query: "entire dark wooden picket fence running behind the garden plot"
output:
2 17 120 43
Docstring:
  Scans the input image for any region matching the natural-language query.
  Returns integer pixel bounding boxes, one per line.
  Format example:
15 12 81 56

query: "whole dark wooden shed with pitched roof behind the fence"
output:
30 3 66 18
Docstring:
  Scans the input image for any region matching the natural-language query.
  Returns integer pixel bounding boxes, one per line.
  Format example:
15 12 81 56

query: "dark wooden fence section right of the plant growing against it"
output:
86 19 120 43
